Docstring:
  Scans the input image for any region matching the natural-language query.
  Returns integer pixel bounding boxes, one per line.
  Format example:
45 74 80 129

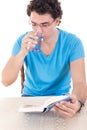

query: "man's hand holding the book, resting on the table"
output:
54 95 81 118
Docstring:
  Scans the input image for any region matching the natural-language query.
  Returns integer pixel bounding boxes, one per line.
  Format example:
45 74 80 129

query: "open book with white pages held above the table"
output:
19 96 71 112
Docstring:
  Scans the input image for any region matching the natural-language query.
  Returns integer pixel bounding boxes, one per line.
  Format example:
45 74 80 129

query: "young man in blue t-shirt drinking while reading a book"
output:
2 0 87 117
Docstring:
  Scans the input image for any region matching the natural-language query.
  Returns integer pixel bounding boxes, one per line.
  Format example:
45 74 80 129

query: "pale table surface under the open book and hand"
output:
0 97 87 130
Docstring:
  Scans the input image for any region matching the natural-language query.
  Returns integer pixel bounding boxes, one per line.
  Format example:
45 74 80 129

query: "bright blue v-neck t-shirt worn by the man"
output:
12 29 84 96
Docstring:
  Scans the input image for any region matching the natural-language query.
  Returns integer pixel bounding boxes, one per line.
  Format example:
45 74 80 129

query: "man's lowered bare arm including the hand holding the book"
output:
54 58 87 118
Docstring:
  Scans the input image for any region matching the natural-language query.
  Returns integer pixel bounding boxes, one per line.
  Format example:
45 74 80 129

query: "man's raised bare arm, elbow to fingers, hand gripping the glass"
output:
2 32 38 86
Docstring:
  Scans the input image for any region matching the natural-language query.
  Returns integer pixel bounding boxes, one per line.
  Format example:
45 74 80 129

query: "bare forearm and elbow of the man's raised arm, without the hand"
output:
2 51 24 86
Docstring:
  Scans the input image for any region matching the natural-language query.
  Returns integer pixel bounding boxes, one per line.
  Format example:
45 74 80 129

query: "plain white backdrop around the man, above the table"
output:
0 0 87 97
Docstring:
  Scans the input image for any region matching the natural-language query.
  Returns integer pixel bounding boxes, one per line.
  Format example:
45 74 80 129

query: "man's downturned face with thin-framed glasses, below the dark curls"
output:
30 11 58 38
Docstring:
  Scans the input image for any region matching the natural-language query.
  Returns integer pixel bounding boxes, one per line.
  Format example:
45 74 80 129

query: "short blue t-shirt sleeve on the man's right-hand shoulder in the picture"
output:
70 38 85 62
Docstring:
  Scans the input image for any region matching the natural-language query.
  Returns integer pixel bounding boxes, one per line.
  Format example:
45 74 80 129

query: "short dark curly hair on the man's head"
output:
27 0 62 23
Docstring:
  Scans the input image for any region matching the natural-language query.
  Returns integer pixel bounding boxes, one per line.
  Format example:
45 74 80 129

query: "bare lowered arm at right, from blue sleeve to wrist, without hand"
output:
70 58 87 102
